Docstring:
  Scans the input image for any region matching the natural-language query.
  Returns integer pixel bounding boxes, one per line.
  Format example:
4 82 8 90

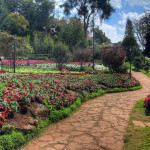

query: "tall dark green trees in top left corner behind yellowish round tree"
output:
0 0 54 42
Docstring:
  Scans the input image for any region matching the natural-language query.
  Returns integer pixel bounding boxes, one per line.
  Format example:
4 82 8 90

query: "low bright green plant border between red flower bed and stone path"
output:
0 85 142 150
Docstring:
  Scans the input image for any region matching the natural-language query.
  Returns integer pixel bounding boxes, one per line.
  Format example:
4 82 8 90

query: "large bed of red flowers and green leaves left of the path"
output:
0 73 140 132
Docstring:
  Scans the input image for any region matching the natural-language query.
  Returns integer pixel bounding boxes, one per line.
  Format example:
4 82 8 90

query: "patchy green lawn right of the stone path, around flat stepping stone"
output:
123 99 150 150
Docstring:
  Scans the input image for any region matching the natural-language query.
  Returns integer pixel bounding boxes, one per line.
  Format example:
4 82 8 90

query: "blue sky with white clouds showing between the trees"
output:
56 0 150 43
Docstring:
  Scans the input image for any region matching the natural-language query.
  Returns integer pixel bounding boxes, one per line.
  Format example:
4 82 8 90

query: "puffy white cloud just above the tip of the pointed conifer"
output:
118 12 144 26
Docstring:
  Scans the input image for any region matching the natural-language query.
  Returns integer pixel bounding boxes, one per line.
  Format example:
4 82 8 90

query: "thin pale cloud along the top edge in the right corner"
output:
125 0 150 6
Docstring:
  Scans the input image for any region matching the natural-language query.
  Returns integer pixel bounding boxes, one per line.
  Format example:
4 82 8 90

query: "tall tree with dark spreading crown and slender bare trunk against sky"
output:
61 0 114 37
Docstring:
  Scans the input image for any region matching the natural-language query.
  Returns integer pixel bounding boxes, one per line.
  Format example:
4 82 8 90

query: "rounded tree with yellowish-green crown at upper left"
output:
3 13 29 36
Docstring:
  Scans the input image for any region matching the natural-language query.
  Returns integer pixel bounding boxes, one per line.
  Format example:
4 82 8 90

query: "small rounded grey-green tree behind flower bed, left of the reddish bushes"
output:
53 42 71 70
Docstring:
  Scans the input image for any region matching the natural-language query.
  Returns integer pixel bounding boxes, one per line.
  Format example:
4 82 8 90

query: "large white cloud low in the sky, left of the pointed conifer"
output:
100 23 124 43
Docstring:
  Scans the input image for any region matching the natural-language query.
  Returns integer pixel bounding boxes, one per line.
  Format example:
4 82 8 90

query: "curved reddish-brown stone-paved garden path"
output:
23 72 150 150
